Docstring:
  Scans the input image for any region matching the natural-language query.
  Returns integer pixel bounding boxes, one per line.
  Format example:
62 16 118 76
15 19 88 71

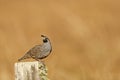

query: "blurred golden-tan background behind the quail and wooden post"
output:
0 0 120 80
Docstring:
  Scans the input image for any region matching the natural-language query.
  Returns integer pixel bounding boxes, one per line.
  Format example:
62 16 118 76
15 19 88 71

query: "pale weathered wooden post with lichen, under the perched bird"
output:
15 61 49 80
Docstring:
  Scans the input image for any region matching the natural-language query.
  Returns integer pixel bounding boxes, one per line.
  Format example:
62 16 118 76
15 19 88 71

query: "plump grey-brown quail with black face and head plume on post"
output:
18 35 52 61
